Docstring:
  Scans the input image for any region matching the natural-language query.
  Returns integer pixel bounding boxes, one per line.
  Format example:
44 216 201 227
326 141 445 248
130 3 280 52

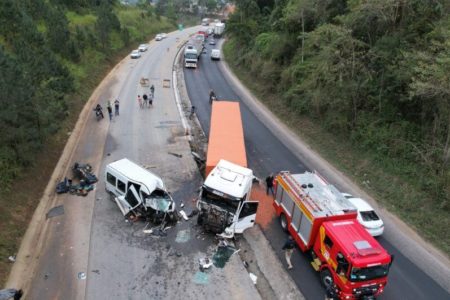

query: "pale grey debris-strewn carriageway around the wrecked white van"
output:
20 29 260 299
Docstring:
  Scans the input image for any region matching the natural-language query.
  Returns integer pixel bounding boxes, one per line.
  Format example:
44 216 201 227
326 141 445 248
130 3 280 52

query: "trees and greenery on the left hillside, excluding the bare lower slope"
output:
0 0 176 191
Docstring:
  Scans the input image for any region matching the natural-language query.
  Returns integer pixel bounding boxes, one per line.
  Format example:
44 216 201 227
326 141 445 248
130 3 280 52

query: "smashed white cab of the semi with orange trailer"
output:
197 160 258 238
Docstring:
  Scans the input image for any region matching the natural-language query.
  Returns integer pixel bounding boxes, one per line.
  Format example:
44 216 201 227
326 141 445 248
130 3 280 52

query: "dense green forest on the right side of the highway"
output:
227 0 450 252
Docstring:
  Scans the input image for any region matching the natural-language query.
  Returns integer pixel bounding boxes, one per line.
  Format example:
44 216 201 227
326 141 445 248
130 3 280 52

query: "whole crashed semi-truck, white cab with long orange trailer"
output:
197 101 258 238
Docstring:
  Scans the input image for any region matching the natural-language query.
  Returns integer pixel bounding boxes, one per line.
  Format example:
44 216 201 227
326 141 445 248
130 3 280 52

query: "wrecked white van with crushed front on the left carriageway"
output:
105 158 176 223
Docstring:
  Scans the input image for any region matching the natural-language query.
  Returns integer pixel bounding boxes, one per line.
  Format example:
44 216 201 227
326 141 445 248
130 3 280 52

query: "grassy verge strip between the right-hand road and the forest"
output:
223 41 450 257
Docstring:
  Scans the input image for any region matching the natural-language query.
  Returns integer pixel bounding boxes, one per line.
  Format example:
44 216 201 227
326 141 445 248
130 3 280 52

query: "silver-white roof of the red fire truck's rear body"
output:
280 172 356 218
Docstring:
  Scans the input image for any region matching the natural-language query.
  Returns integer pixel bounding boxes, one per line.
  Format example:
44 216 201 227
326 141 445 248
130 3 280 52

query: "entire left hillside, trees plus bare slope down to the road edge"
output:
0 0 176 283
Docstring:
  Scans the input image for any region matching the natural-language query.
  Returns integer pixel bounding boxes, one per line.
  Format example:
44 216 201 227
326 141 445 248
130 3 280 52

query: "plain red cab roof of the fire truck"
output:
322 220 390 267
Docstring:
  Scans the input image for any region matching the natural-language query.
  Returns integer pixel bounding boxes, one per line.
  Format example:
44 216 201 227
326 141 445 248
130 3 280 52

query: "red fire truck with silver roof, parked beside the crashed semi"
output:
273 172 392 299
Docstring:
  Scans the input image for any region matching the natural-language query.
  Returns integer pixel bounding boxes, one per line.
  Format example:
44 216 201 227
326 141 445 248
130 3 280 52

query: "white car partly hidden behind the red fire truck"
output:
344 196 384 236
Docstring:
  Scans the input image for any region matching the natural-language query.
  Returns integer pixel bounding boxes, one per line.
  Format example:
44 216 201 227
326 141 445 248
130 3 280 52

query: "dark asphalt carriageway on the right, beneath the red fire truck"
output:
184 38 450 299
